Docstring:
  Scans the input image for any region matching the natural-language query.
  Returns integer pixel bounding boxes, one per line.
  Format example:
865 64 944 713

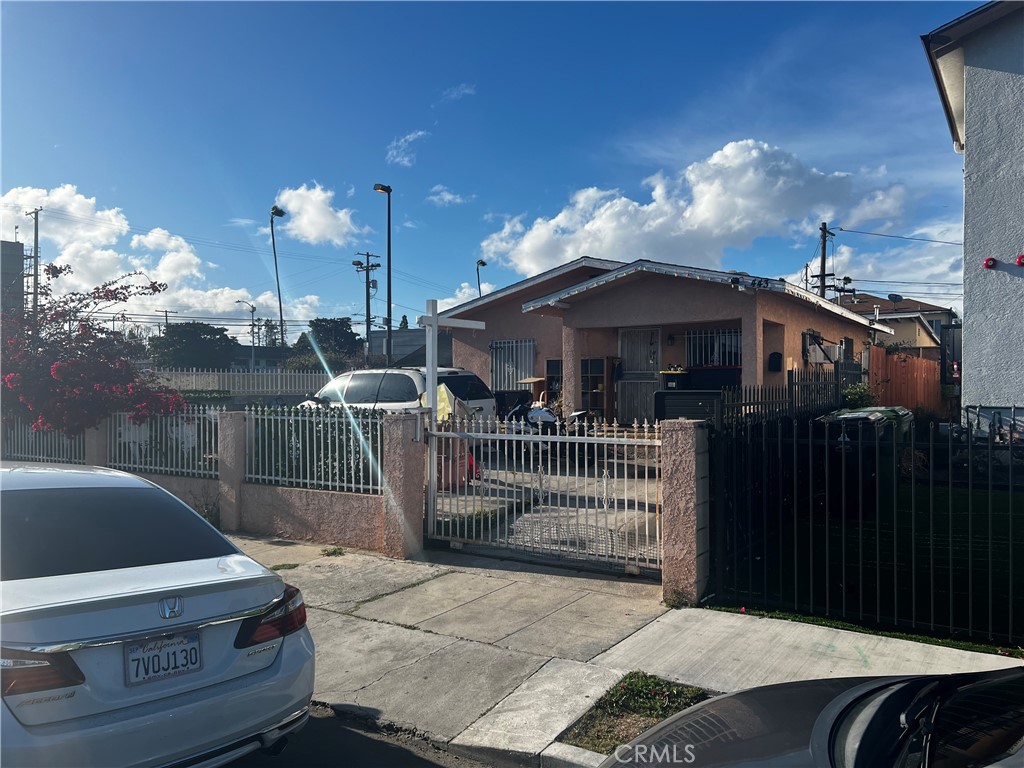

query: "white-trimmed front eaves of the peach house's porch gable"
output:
522 259 894 334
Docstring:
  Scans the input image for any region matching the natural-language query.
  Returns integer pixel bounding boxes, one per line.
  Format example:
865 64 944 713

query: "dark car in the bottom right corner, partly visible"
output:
601 667 1024 768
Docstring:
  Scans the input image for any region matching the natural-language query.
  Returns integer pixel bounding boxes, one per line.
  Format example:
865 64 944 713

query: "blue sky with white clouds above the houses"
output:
0 1 980 341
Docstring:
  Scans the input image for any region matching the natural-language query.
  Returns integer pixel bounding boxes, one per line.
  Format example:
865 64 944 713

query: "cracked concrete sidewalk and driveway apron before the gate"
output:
231 537 1020 766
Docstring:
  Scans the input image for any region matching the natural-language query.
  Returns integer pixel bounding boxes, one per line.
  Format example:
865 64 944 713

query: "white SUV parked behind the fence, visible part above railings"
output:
303 368 496 419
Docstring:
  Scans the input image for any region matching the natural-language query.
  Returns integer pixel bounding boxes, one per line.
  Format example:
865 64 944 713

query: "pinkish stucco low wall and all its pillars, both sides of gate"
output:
85 412 712 605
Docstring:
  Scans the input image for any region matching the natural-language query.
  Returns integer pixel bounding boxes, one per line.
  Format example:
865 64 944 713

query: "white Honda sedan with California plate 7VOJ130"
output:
0 463 314 768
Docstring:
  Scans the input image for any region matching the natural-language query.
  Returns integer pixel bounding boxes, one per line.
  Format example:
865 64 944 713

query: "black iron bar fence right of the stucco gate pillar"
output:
711 409 1024 643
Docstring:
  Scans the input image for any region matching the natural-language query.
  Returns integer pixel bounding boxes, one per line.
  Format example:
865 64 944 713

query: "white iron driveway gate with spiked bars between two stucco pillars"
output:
426 422 662 574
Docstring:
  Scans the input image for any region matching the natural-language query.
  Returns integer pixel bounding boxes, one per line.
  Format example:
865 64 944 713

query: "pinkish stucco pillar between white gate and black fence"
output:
662 420 711 606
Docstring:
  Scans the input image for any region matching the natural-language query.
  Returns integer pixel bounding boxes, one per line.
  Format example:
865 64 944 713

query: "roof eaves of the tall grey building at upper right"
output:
921 2 1024 154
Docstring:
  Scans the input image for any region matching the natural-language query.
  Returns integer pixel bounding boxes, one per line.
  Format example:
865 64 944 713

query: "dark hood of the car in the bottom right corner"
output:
602 678 883 768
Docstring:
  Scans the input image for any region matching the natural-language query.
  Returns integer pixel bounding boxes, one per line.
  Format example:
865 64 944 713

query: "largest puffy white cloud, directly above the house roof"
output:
480 139 903 275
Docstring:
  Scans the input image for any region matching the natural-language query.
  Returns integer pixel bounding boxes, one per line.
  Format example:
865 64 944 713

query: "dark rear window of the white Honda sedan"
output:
0 488 237 582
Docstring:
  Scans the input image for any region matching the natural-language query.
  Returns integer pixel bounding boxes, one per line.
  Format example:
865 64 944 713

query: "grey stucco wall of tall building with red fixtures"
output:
962 10 1024 406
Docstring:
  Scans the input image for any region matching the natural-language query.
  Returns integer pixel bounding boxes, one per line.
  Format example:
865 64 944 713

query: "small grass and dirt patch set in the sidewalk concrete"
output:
558 672 712 755
